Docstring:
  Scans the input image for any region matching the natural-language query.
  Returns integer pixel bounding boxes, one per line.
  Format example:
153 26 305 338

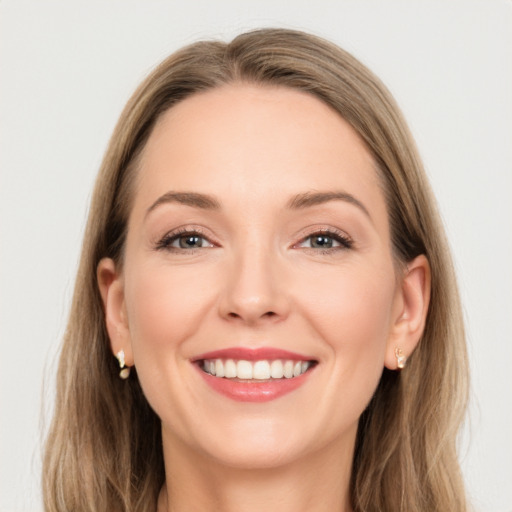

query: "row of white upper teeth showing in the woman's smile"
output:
202 359 311 380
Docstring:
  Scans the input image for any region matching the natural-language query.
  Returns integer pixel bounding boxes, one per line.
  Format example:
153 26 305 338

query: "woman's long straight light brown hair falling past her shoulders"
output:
43 29 467 512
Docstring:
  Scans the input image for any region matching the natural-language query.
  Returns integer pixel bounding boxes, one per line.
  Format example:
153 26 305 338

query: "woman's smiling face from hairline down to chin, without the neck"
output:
99 85 416 467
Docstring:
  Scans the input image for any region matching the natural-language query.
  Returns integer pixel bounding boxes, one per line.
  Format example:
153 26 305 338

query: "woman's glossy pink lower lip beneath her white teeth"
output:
197 366 312 402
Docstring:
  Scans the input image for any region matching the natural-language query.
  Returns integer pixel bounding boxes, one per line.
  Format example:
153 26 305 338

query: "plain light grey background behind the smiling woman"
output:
0 0 512 512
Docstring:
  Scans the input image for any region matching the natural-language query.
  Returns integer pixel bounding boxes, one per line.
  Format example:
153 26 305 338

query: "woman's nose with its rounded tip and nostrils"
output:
219 247 290 325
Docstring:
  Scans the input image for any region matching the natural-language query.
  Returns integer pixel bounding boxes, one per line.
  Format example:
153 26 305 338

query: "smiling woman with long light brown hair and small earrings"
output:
44 29 467 512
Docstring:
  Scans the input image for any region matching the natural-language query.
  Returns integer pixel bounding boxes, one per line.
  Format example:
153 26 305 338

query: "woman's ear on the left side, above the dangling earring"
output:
96 258 133 366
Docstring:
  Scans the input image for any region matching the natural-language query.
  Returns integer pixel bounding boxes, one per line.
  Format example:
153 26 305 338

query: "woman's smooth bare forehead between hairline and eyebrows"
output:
132 84 382 221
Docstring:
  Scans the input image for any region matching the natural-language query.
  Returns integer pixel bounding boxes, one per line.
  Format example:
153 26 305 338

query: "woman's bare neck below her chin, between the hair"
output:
158 428 354 512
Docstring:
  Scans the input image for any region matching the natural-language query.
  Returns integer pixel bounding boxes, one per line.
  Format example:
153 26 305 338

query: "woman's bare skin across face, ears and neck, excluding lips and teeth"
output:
98 85 429 511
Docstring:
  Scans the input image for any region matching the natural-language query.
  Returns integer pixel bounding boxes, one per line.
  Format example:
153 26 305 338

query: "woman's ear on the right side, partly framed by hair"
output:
384 254 430 370
